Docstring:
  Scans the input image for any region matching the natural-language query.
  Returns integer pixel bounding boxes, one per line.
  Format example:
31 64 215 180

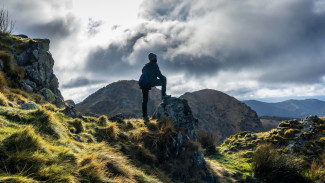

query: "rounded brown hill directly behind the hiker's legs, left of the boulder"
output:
76 80 161 117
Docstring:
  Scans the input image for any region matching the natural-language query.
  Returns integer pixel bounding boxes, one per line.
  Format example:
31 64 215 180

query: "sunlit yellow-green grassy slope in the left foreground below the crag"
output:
0 89 168 182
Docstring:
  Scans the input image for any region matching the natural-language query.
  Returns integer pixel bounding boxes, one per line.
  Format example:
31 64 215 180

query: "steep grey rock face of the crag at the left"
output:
12 38 64 107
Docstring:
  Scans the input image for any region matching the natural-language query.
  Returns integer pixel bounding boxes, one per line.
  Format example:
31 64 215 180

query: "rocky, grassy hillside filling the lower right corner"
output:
208 116 325 183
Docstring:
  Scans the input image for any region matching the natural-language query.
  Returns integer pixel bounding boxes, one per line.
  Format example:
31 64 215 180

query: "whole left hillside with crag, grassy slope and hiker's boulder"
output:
0 34 232 183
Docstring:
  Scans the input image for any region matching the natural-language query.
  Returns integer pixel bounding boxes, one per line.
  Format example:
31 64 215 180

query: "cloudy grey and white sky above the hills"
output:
0 0 325 103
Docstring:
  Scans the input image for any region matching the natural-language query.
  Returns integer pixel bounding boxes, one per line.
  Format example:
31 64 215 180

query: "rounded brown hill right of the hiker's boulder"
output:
180 89 263 141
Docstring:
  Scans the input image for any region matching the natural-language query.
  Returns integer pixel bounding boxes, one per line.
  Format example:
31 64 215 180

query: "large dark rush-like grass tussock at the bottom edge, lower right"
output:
252 144 307 183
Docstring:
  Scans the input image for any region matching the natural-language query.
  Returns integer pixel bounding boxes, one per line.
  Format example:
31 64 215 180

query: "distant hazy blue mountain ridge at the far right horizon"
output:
243 99 325 118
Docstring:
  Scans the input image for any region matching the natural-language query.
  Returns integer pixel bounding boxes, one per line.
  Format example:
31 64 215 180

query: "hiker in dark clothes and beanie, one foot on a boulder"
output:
139 53 170 123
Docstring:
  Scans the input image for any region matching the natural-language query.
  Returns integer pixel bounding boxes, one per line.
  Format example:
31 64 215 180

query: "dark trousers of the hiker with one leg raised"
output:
142 77 167 117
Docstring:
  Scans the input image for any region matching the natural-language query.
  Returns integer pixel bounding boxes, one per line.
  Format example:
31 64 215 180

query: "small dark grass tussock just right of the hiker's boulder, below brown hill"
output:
199 131 217 155
